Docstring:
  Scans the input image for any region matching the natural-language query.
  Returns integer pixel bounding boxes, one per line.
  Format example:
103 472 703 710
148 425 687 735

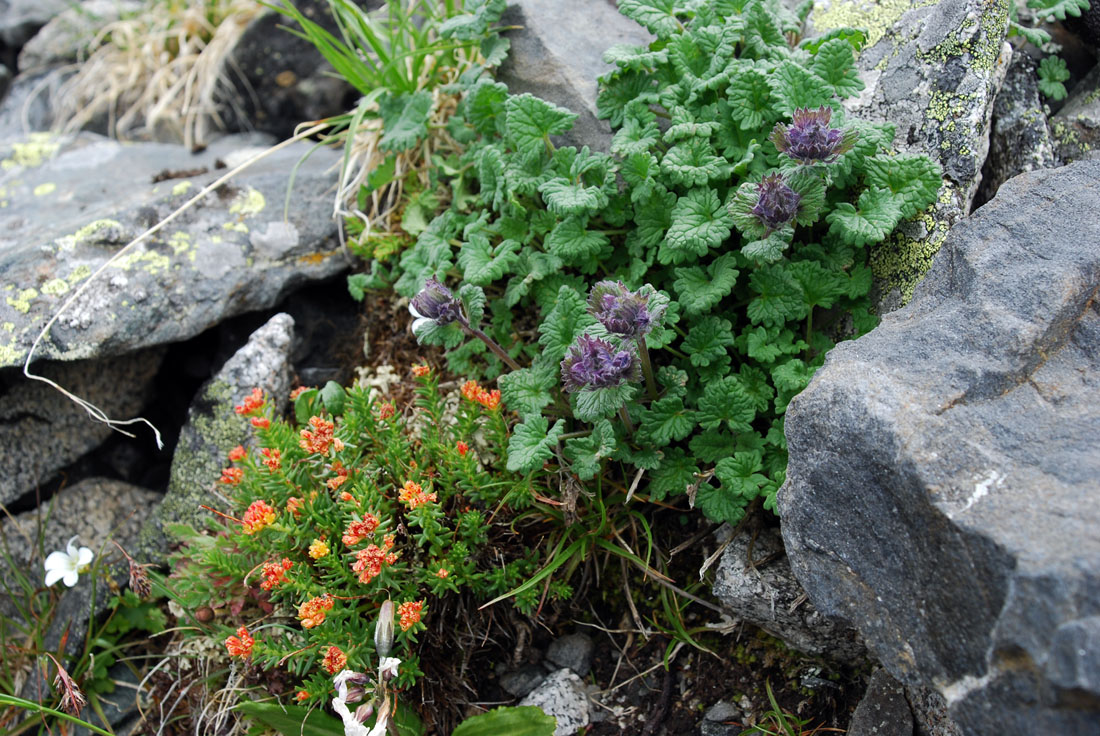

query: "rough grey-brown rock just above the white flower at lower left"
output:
0 477 161 616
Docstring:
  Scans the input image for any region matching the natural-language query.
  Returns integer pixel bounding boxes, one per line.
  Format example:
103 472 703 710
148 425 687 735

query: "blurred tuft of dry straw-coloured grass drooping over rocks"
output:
52 0 263 146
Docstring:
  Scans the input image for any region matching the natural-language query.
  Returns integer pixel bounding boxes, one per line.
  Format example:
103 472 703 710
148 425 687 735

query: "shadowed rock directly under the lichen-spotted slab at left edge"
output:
0 347 164 505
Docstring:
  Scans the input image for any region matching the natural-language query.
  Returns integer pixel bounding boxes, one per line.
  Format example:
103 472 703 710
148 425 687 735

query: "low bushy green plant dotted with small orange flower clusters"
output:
172 366 571 703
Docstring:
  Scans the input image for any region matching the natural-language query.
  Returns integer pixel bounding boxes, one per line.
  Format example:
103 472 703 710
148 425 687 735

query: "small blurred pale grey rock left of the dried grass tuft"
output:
19 0 141 72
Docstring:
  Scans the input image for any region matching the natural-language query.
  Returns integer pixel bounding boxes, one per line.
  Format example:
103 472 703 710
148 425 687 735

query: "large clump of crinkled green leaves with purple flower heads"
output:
382 0 942 521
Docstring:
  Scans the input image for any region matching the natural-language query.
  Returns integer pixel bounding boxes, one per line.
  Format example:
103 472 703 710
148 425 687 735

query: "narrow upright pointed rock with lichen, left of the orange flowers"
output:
138 314 294 564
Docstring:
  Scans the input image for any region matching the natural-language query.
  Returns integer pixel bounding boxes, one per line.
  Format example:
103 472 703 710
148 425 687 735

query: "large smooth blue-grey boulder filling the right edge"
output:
779 161 1100 734
